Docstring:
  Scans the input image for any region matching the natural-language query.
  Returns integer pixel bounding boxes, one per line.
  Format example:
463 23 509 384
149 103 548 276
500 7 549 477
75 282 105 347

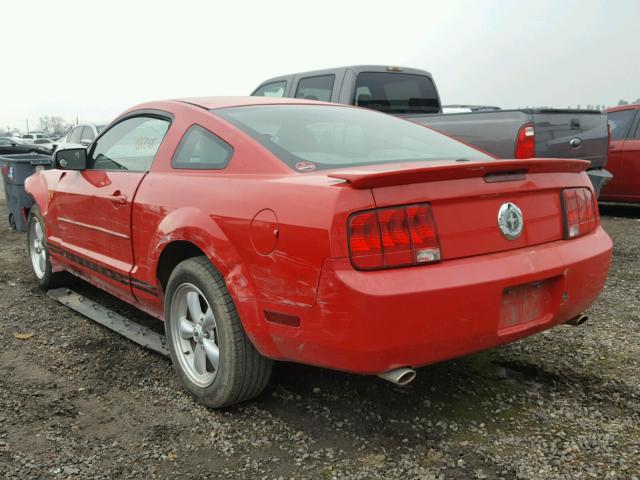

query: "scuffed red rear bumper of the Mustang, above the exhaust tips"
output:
245 227 612 374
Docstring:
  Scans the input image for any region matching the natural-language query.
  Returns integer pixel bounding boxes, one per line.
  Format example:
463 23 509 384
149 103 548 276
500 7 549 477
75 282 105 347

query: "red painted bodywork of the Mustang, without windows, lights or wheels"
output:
26 97 611 373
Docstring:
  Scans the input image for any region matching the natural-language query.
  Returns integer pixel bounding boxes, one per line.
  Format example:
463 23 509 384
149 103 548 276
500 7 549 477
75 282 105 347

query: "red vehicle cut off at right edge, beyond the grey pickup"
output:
599 104 640 203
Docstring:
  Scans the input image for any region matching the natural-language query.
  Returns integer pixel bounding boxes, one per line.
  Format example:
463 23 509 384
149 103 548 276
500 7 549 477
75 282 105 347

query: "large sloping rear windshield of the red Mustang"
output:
212 105 491 171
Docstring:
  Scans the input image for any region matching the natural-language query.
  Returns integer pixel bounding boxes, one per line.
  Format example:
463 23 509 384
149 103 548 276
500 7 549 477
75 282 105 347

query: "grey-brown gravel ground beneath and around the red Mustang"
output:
0 187 640 480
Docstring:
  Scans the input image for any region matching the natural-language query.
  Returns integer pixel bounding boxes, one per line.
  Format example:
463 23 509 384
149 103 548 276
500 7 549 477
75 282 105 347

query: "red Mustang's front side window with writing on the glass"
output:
88 116 170 172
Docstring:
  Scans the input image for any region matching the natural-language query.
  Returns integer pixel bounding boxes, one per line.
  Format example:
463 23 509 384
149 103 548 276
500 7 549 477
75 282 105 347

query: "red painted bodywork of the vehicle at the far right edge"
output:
599 105 640 203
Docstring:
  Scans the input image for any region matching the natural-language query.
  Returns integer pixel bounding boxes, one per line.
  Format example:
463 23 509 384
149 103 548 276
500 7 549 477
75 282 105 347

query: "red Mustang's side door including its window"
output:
49 114 170 299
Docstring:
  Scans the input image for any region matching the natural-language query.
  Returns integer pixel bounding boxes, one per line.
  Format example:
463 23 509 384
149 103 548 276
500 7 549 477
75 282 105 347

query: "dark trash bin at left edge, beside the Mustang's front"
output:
0 153 51 232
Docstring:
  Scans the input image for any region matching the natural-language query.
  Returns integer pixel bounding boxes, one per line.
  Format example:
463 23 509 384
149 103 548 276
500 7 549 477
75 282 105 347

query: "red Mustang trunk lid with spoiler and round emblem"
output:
329 159 588 260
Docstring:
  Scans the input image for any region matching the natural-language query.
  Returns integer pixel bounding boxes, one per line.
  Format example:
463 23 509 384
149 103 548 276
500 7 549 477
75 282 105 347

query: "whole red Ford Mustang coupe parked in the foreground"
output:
26 97 611 407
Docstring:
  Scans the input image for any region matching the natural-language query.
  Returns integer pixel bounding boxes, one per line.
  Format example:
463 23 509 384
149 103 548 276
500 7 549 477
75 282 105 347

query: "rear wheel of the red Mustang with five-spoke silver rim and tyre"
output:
164 257 273 408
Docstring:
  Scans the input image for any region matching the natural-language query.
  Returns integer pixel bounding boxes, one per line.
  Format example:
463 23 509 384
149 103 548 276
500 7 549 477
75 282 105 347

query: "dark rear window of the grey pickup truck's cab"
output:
353 72 440 113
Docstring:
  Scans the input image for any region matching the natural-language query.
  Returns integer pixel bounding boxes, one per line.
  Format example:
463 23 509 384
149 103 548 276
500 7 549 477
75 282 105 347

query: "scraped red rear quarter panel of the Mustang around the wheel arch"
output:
132 102 373 331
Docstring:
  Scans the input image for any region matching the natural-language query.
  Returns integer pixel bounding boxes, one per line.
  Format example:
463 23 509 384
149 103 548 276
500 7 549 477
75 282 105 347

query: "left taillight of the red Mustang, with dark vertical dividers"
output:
349 203 441 270
